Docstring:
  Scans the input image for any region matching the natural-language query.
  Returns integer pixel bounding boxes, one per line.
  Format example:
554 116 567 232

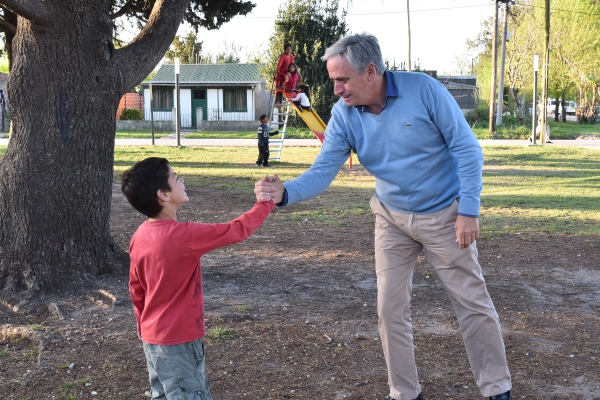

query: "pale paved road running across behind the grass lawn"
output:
0 139 600 150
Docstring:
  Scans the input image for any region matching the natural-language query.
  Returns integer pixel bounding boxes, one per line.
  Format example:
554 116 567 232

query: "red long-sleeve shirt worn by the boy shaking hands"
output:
129 201 275 345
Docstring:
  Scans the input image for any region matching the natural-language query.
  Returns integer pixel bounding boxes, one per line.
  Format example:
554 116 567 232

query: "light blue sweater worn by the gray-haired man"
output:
284 71 483 216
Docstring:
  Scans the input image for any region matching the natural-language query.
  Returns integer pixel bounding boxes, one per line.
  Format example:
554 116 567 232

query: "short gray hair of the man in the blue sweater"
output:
321 32 385 75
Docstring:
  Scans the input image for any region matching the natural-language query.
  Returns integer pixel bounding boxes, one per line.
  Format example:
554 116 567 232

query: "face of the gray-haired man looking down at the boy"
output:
327 56 372 107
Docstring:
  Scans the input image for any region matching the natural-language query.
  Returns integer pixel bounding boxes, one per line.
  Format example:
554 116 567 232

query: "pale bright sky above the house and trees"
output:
186 0 494 75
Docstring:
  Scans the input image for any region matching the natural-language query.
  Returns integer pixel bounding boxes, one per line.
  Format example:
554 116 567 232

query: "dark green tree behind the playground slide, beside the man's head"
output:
261 0 348 121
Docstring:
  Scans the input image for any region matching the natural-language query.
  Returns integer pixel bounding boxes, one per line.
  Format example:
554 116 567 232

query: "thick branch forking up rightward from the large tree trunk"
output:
114 0 190 90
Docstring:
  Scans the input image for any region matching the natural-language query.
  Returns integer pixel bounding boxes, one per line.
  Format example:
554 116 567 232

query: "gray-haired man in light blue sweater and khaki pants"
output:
275 34 511 400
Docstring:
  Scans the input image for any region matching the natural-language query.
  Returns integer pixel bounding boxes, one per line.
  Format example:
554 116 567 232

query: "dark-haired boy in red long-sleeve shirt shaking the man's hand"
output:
121 157 277 400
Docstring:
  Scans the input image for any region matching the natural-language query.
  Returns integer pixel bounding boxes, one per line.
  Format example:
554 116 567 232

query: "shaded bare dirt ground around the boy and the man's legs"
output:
0 175 600 400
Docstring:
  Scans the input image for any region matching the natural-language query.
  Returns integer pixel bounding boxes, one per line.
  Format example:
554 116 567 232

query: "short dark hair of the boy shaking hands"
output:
121 157 171 218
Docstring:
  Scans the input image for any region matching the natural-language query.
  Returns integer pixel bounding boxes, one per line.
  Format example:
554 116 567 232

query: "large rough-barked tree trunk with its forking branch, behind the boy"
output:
0 0 189 296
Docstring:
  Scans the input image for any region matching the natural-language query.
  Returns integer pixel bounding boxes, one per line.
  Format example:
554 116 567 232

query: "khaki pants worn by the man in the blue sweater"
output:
371 196 511 400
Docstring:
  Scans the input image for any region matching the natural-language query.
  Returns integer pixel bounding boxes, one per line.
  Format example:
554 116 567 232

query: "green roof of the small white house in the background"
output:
149 64 263 85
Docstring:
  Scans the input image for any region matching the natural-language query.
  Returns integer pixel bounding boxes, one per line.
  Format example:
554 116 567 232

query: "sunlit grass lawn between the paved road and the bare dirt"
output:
0 146 600 236
